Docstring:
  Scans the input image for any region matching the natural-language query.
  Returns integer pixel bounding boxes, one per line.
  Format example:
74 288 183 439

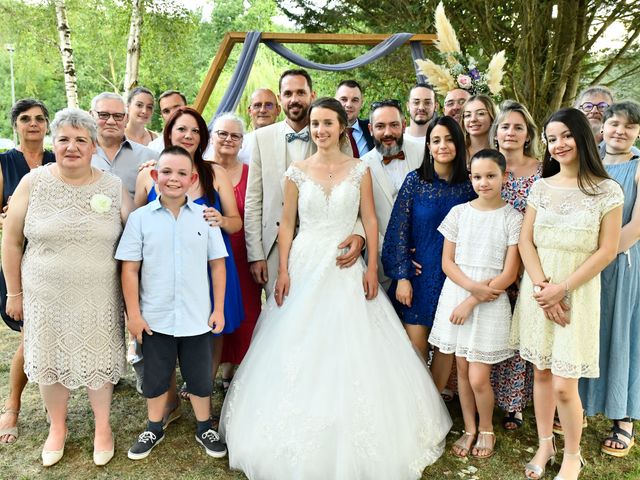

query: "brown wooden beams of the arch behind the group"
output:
193 32 437 113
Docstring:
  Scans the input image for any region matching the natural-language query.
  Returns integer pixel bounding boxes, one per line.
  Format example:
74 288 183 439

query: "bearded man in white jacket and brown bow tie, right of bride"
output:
362 100 425 284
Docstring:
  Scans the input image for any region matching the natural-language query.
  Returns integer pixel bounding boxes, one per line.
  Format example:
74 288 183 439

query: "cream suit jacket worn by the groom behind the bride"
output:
244 121 353 262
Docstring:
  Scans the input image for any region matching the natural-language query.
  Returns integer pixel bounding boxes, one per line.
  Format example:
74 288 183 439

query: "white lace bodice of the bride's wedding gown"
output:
285 162 368 243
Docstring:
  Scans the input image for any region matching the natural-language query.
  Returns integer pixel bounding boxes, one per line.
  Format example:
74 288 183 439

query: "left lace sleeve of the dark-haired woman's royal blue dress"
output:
382 172 420 280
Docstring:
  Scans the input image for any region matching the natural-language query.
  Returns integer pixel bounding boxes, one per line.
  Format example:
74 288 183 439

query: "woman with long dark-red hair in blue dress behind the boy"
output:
134 107 245 404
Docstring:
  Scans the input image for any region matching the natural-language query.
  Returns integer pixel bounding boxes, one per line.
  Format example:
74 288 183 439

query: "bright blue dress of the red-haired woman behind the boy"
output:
147 185 244 335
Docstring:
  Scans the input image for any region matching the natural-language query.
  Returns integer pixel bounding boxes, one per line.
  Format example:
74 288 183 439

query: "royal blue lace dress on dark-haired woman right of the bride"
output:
382 171 476 327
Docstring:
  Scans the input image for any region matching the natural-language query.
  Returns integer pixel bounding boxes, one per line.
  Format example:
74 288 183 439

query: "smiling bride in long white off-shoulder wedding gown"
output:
221 98 451 480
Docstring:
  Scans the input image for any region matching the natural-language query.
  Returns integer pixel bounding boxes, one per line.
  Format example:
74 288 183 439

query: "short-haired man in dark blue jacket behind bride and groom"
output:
336 80 373 158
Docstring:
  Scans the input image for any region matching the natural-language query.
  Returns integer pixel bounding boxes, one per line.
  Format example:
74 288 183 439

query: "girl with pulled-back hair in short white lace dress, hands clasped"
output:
429 149 522 458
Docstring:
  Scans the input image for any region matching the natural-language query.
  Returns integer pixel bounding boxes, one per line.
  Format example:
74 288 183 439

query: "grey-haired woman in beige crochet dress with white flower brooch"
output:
2 109 131 466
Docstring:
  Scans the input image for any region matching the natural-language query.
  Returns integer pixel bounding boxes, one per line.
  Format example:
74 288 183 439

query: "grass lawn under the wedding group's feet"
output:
0 325 640 480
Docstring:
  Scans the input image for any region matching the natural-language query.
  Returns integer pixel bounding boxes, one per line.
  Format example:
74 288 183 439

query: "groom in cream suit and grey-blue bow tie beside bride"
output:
244 70 364 295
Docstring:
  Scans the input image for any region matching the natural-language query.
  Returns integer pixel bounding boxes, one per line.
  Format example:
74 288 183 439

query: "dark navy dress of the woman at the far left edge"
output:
0 148 56 332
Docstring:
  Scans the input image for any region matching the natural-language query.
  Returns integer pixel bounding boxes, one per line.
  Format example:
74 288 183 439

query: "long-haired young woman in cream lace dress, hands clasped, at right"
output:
511 108 623 480
